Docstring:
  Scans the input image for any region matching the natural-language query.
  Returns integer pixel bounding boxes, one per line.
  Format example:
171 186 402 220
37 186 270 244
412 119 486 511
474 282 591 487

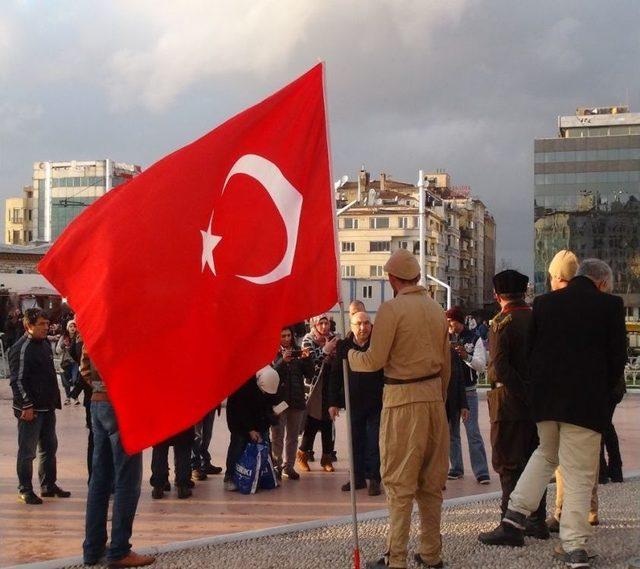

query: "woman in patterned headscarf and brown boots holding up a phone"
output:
297 314 338 472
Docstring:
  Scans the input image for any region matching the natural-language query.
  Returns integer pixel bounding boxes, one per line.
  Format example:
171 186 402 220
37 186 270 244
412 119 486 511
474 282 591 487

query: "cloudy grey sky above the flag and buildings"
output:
0 0 640 271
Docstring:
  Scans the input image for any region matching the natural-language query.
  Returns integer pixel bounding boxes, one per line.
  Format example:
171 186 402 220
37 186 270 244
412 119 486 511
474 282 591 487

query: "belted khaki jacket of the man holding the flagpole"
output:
349 286 451 407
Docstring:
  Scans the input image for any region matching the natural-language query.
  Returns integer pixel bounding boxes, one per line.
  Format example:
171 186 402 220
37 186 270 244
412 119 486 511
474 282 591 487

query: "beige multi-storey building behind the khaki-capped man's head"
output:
336 170 495 308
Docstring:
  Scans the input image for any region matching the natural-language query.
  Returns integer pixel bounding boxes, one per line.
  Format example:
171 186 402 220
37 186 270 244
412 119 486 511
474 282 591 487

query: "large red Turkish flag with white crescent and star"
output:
38 64 338 452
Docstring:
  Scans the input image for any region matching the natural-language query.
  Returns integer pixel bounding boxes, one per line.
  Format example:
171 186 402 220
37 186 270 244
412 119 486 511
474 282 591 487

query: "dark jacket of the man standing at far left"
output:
9 334 61 415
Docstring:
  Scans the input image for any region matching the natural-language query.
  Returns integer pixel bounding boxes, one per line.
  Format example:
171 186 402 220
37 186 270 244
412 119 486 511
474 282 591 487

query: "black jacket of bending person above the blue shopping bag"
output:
227 375 276 436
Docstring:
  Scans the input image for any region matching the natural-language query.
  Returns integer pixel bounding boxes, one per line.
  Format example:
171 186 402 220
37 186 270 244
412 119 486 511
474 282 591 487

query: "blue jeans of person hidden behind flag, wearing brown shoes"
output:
82 401 142 563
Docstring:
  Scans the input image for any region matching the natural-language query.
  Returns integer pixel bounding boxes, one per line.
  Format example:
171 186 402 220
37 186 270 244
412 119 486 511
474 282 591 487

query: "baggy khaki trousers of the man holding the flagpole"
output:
380 401 449 567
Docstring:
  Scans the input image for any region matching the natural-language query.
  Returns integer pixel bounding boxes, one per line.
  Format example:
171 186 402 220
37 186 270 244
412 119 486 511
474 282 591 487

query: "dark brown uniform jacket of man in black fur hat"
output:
487 300 533 423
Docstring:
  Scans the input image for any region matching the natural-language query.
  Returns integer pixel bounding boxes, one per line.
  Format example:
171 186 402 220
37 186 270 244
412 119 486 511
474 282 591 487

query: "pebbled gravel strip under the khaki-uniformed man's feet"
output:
60 480 640 569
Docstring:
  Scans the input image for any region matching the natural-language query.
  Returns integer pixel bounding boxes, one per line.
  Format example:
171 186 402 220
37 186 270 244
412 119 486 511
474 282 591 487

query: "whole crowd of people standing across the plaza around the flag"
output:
9 246 626 568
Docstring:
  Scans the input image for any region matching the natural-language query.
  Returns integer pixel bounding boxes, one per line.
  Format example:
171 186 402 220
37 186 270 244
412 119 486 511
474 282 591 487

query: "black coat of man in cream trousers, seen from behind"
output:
529 276 627 433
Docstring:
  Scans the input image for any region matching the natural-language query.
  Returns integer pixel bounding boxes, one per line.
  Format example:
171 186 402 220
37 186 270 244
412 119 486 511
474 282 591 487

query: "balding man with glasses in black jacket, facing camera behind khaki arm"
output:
329 312 384 496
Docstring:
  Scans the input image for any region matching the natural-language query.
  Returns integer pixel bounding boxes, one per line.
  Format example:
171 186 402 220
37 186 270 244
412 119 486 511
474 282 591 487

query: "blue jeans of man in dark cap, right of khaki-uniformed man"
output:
449 389 489 479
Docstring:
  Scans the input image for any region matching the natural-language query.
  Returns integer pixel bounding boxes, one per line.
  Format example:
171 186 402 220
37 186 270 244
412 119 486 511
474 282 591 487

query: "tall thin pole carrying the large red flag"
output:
321 61 360 569
